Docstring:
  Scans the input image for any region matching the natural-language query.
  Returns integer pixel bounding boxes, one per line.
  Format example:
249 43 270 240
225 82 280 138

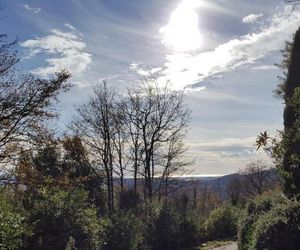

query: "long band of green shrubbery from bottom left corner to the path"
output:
0 186 244 250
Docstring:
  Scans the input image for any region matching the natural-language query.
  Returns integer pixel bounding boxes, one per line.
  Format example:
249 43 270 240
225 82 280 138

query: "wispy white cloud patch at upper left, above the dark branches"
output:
21 29 92 76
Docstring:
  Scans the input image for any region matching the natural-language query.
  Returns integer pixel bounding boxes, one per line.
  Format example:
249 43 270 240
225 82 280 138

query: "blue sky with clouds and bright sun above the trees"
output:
0 0 300 175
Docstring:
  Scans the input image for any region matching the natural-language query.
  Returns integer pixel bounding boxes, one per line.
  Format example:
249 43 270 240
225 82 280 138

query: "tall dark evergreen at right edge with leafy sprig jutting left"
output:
256 29 300 197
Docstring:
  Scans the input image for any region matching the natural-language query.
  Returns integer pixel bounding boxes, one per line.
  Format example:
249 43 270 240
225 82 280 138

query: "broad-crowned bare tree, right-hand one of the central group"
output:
123 78 190 198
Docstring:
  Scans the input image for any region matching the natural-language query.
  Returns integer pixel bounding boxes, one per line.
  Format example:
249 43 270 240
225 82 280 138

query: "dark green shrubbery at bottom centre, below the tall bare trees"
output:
104 200 202 250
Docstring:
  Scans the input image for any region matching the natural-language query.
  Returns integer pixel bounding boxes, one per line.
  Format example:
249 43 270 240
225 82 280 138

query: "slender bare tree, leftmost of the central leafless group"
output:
71 82 116 212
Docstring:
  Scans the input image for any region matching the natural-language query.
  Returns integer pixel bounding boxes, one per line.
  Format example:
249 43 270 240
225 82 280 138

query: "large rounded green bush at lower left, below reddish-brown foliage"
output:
29 188 104 249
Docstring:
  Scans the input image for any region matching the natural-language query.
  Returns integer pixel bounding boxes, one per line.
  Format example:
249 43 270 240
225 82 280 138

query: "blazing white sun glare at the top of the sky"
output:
159 0 202 52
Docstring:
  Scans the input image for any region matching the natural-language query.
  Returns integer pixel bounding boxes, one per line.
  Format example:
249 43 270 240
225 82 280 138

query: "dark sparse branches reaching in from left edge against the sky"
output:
0 35 70 166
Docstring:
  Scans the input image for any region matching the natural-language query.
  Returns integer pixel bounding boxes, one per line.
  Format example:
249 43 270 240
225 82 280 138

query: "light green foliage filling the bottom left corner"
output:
0 190 31 250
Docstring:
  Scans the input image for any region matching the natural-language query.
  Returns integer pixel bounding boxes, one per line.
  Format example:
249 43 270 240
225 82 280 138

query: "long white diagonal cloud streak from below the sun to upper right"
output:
163 7 300 89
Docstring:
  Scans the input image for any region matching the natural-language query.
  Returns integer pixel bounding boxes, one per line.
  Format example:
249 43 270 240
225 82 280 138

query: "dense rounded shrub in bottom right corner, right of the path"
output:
239 194 300 250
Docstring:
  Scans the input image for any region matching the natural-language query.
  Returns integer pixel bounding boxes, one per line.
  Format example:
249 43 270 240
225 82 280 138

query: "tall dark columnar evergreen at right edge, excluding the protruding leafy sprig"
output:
279 26 300 197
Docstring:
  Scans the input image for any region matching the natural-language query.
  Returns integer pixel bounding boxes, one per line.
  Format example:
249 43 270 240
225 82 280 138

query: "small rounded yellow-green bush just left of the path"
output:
205 205 240 240
